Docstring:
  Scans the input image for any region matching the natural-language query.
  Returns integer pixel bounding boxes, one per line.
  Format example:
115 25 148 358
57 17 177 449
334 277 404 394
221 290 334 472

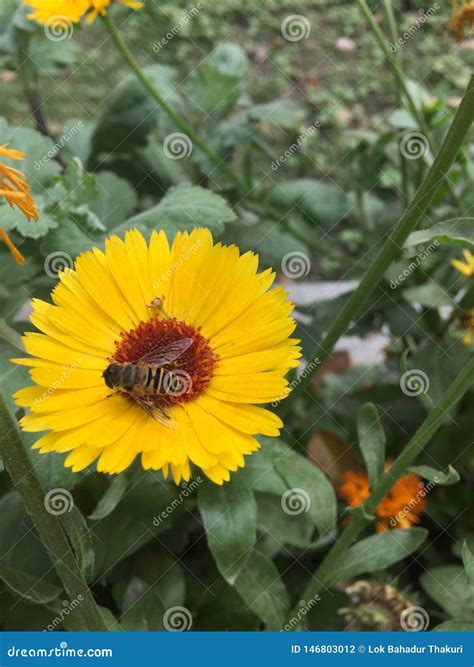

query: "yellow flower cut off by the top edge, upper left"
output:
22 0 144 27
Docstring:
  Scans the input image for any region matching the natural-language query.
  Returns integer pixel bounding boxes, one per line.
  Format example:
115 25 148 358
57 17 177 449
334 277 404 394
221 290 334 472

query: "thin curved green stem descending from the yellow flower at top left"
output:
102 12 240 184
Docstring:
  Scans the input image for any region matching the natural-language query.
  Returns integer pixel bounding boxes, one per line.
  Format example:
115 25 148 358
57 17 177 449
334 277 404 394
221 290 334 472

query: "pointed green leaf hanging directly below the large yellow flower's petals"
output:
198 475 257 585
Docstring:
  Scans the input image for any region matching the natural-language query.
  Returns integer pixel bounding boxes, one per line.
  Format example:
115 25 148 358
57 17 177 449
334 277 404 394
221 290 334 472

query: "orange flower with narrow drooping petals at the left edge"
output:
0 145 39 264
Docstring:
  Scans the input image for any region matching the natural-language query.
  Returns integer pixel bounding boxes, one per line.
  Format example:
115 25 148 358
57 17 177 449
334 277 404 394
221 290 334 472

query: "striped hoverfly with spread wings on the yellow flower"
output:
102 338 193 428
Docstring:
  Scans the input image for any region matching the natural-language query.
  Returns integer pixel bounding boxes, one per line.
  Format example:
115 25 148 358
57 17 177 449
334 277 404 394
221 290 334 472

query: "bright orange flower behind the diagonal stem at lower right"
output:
337 461 426 532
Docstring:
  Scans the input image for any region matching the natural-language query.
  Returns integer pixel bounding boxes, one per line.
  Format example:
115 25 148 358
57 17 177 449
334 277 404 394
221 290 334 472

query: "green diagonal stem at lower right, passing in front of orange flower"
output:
290 359 474 619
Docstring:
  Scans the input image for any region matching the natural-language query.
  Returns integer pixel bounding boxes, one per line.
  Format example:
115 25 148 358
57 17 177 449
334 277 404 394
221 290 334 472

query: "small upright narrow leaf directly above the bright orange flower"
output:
357 403 386 487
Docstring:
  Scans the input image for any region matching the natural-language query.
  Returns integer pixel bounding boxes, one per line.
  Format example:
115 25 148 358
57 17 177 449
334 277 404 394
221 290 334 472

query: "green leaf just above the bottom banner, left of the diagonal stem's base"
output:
235 549 290 630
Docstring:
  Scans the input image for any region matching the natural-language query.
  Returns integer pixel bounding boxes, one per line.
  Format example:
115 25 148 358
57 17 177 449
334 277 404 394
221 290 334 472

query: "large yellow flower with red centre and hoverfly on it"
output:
14 229 300 484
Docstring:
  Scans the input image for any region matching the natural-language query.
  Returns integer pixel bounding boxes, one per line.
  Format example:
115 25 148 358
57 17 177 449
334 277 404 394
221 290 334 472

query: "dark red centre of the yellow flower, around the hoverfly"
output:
110 318 217 408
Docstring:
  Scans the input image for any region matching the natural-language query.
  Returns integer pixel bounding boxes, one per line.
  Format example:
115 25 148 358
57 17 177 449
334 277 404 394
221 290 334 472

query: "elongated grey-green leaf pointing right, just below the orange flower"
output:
331 528 428 583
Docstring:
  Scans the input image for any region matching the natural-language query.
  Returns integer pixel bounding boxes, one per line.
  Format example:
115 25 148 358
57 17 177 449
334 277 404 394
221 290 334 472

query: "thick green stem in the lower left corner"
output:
0 395 108 630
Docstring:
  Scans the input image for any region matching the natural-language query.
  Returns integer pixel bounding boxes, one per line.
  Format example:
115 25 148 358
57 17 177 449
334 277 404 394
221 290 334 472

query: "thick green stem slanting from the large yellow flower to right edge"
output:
282 75 474 414
